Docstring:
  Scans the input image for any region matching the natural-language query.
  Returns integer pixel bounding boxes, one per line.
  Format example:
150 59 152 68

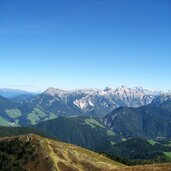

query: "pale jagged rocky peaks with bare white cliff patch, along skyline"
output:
31 86 157 117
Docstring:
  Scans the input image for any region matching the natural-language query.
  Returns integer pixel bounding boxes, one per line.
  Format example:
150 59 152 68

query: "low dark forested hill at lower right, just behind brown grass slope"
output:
106 137 171 165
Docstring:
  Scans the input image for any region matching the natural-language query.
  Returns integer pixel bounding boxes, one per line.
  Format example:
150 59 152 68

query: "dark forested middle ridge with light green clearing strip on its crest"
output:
34 116 121 152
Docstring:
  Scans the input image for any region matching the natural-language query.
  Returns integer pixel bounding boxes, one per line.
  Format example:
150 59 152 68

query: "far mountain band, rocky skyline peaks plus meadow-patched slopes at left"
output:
0 86 171 126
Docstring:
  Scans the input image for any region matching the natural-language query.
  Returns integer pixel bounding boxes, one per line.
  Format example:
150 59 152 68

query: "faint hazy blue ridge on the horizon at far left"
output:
0 88 36 98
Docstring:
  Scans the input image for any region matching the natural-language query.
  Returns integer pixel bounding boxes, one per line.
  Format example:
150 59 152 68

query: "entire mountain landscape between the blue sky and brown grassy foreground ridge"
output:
0 86 171 167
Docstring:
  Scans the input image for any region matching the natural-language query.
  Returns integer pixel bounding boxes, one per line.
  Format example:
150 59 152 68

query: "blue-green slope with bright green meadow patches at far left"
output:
0 96 56 126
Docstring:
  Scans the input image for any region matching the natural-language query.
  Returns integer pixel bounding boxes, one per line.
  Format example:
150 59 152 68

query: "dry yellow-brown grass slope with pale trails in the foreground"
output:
3 134 171 171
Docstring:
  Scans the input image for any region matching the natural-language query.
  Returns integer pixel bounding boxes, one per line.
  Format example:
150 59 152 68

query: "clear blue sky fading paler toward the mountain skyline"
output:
0 0 171 90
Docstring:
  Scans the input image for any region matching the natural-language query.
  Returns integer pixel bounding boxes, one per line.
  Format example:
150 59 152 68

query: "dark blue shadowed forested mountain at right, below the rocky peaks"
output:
104 100 171 138
